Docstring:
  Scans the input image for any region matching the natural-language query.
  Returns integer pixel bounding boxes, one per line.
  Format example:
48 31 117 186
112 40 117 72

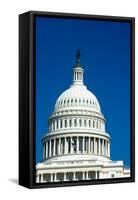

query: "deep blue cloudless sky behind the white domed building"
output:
36 17 130 166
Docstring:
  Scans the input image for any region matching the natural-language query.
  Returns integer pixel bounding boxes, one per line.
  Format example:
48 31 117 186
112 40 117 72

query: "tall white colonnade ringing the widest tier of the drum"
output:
43 136 110 160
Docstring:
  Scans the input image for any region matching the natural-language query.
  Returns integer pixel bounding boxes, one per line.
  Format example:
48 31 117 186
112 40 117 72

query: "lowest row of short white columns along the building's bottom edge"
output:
36 171 99 183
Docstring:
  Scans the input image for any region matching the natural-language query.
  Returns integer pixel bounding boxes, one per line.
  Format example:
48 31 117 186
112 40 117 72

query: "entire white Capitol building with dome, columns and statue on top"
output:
36 50 130 183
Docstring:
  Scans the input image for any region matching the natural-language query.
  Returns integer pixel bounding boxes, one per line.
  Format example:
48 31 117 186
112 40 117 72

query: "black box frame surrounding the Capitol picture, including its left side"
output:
19 11 135 188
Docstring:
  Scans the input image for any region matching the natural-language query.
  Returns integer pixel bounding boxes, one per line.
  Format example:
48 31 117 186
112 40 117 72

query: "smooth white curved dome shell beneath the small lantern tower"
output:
55 84 101 113
